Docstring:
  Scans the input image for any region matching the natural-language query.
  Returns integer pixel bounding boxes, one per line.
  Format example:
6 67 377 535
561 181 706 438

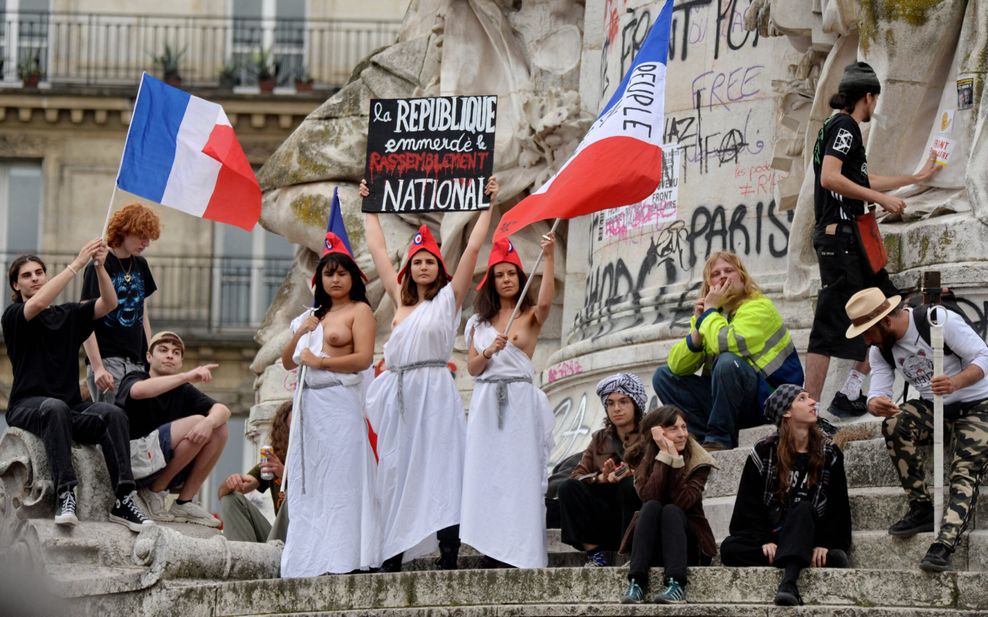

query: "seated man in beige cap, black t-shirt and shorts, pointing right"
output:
117 331 230 527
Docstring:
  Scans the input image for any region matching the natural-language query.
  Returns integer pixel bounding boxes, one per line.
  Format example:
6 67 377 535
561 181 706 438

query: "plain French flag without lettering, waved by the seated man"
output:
117 73 261 231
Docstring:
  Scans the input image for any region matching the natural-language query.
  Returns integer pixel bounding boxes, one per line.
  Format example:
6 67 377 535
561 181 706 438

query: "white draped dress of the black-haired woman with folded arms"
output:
281 313 381 578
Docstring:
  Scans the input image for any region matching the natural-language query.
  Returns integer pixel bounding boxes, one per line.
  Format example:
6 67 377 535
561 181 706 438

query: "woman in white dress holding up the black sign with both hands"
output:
360 177 498 572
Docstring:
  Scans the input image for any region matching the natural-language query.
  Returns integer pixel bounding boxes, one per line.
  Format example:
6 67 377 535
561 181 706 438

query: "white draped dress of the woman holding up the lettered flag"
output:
460 316 554 568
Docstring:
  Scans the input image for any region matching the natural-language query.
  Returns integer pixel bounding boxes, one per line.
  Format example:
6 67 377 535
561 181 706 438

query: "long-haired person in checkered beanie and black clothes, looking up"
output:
720 384 851 606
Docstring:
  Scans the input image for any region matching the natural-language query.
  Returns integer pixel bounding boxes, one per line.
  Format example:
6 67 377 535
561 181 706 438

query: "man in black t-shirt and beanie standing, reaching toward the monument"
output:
806 62 939 417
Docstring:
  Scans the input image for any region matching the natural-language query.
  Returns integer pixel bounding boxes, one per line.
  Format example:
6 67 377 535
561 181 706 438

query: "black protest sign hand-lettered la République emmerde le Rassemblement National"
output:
362 96 497 213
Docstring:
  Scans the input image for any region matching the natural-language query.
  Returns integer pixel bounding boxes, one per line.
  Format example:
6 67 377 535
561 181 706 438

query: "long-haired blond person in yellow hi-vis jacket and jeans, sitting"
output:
652 251 803 450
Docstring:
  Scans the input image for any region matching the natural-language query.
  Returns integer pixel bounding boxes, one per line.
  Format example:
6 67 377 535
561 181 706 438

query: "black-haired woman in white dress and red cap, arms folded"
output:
281 232 381 578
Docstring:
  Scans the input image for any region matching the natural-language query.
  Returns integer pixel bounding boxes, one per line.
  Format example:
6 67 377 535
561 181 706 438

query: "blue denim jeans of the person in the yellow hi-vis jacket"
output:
652 352 765 448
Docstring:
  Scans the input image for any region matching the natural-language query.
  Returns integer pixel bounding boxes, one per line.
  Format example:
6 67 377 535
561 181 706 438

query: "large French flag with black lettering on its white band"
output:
494 0 673 242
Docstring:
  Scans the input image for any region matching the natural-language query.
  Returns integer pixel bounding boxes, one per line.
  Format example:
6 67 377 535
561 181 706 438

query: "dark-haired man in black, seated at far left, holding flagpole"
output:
2 238 153 531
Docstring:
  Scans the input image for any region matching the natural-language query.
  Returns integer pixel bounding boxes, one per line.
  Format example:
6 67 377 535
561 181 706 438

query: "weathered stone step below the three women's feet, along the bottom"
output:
191 567 988 617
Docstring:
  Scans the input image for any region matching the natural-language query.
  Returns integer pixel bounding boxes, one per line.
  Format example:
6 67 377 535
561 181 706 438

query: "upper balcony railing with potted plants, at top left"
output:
0 11 400 89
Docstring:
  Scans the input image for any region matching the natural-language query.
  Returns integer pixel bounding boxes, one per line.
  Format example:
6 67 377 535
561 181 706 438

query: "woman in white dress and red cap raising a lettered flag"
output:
460 234 555 568
